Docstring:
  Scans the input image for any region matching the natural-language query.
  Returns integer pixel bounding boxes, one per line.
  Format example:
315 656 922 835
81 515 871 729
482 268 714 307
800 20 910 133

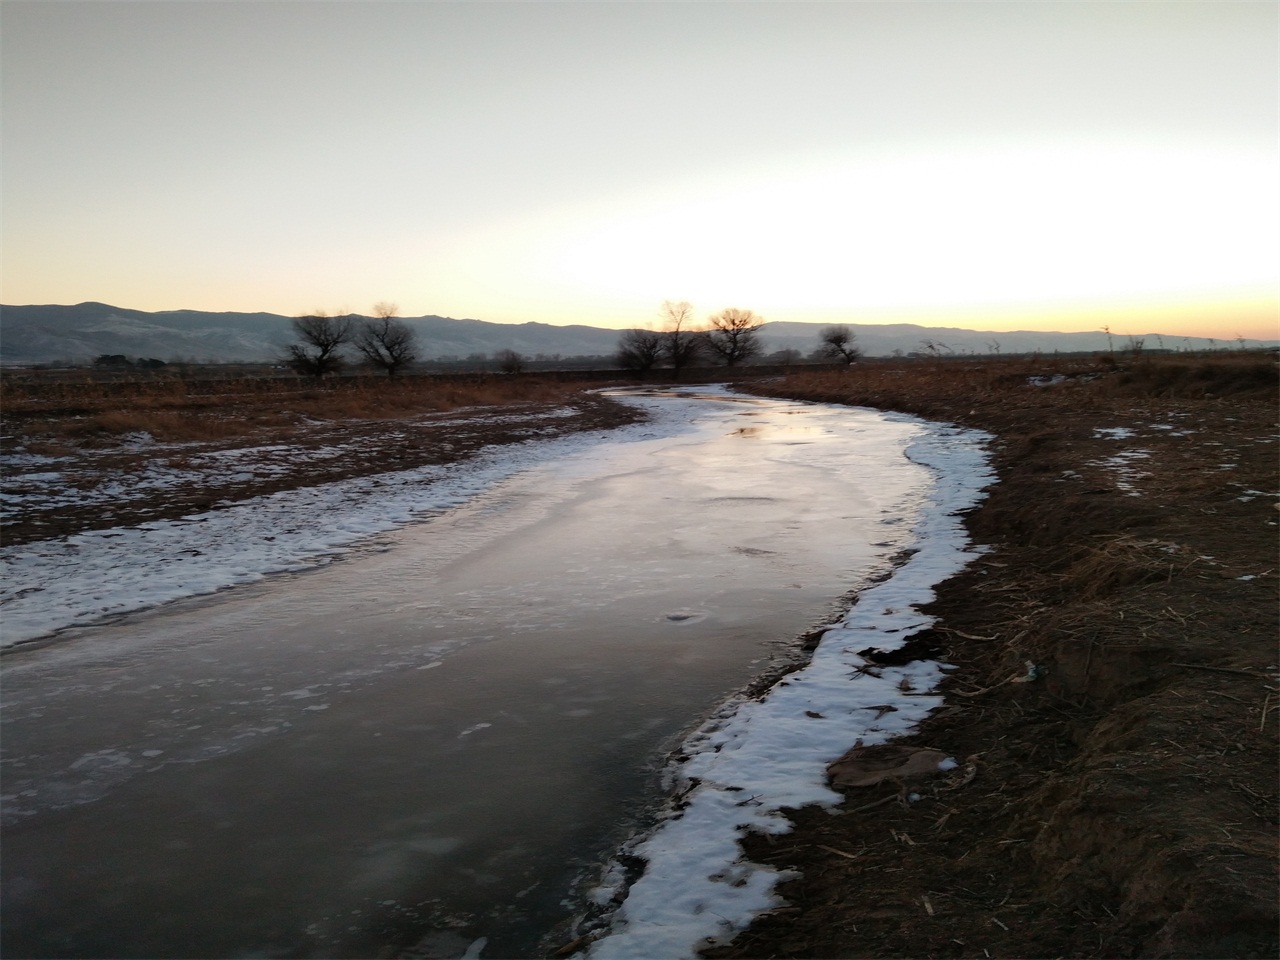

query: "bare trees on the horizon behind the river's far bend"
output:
616 300 861 376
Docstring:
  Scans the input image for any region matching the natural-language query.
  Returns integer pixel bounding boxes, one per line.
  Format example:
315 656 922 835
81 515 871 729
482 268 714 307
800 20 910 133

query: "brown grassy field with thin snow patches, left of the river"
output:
0 375 639 544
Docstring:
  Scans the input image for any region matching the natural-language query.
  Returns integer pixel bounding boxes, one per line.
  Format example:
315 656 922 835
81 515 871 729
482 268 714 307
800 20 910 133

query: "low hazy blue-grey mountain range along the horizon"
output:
0 302 1264 366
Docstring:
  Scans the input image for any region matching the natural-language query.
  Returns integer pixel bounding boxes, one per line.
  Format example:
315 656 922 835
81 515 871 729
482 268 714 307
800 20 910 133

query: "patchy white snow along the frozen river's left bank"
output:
0 404 695 648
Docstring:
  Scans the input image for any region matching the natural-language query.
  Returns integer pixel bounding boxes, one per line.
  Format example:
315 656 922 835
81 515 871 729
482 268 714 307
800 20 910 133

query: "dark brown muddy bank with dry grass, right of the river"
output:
707 356 1280 957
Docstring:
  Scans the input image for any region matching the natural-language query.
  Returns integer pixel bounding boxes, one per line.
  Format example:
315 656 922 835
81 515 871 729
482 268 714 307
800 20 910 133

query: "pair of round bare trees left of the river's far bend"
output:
284 302 417 378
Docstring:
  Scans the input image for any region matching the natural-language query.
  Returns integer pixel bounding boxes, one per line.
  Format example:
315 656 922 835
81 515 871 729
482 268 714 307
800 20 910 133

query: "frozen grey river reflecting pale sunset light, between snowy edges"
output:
0 389 988 957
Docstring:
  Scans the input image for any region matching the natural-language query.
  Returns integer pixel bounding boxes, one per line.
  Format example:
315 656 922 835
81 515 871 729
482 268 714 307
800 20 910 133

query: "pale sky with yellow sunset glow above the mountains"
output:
0 0 1280 339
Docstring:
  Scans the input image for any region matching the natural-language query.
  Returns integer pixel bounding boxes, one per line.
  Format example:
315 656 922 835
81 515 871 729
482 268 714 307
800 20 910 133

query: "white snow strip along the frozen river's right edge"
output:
590 415 993 960
